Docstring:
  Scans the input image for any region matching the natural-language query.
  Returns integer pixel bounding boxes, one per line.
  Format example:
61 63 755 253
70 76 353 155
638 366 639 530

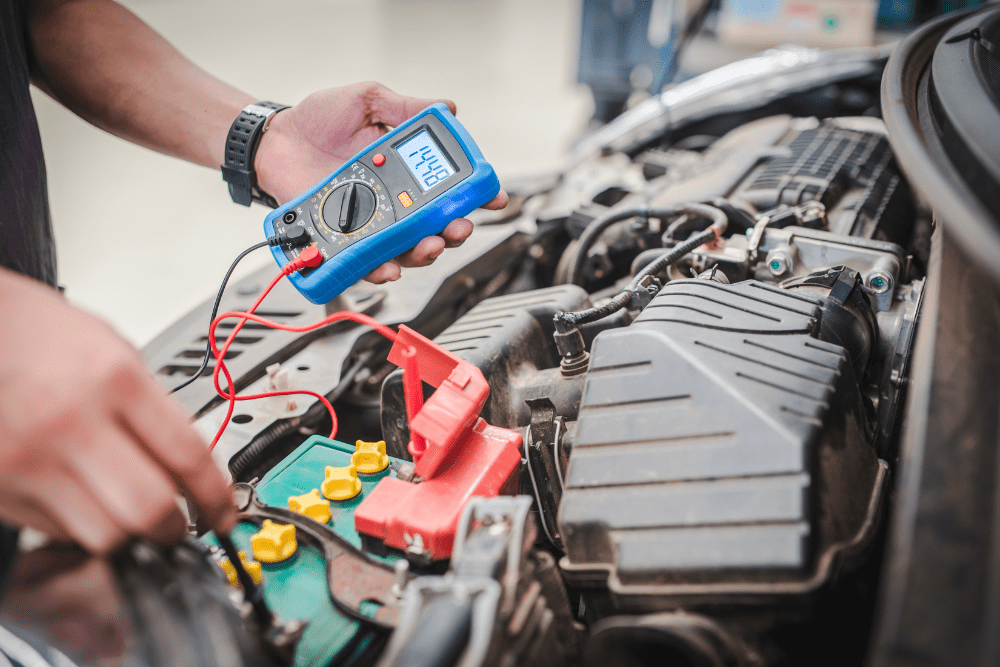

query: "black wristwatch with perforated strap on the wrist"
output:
222 102 288 208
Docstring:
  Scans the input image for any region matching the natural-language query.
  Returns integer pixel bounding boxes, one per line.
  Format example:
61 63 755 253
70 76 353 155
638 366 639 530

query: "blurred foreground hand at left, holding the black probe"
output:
0 270 235 554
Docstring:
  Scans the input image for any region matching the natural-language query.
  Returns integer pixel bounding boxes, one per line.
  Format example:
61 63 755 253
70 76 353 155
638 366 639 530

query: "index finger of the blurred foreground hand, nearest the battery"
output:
118 373 236 532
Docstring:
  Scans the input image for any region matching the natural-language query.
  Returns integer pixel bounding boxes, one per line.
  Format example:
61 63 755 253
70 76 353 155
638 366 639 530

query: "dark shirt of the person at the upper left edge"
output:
0 0 56 286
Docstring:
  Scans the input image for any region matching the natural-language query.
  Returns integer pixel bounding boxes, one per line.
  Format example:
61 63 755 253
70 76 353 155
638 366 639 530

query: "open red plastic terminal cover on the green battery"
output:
354 326 521 560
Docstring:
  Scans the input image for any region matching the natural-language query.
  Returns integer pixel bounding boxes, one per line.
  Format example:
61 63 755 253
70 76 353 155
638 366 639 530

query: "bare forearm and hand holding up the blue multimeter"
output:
29 0 506 282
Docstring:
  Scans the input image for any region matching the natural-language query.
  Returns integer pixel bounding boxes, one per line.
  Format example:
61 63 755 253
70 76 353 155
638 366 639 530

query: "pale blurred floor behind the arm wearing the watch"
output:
32 0 592 346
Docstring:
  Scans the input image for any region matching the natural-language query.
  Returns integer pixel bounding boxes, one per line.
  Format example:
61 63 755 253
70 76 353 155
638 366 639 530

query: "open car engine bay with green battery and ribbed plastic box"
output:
129 41 932 667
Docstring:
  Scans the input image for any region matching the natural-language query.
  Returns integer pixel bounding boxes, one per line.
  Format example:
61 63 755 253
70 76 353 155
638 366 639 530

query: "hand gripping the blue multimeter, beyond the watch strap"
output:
255 83 507 283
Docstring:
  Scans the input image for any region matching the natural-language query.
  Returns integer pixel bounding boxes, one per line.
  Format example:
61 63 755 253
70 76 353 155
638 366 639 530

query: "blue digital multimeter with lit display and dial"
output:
264 103 500 304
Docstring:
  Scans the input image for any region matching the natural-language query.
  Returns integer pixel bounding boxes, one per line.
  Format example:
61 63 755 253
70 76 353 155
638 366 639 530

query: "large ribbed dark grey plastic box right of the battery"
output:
559 280 884 599
